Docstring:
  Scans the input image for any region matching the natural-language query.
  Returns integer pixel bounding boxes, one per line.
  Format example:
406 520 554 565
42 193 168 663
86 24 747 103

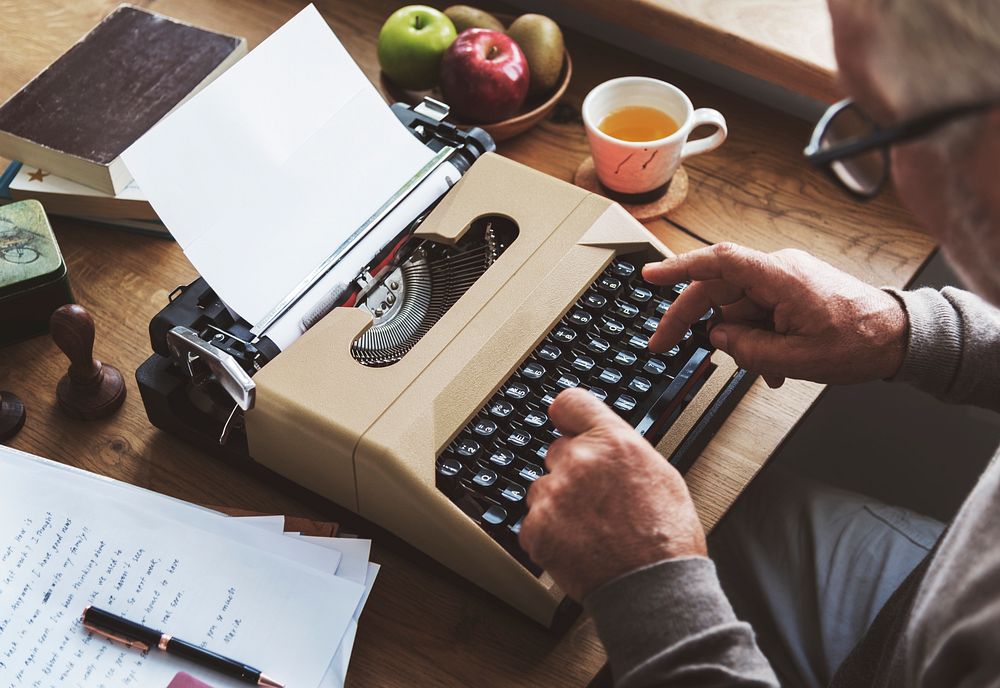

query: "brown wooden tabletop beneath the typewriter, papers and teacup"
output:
0 0 933 687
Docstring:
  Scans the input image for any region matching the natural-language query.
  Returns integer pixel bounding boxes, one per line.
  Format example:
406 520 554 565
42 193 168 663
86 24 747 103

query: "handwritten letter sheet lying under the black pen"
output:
0 447 362 688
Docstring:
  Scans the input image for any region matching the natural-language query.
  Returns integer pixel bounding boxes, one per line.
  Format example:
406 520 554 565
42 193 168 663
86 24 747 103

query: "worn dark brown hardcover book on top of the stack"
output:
0 5 246 193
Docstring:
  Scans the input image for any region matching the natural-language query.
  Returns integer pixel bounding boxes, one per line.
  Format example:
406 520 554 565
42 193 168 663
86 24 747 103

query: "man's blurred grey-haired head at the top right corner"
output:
829 0 1000 305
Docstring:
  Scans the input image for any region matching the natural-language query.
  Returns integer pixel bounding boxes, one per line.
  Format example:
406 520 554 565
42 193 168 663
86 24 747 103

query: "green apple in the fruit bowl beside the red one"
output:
378 5 456 91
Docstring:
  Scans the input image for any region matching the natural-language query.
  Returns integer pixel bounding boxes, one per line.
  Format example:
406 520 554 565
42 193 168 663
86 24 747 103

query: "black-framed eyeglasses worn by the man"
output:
804 98 1000 200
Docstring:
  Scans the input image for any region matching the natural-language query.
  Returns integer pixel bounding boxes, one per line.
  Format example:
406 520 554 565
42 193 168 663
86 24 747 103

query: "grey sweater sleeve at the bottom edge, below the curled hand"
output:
584 557 778 688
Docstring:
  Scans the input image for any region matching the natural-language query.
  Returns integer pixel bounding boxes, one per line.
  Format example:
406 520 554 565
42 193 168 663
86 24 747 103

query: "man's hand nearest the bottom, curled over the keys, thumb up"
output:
520 389 705 600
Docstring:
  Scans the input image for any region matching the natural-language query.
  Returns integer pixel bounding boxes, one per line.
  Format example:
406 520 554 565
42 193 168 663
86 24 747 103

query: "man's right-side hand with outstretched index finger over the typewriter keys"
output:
642 244 907 387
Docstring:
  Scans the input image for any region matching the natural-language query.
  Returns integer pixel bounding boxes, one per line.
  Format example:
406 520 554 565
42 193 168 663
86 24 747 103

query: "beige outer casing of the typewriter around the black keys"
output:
246 154 735 625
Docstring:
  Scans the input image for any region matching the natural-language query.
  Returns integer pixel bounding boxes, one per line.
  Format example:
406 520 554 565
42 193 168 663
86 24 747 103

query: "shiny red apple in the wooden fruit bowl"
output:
441 29 528 123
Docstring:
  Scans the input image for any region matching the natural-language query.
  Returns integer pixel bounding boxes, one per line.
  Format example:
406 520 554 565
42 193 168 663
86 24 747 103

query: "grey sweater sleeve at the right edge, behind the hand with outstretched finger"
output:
887 287 1000 411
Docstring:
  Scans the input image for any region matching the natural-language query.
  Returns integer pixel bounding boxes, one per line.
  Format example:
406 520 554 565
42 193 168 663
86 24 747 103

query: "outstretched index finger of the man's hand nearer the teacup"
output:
642 243 785 305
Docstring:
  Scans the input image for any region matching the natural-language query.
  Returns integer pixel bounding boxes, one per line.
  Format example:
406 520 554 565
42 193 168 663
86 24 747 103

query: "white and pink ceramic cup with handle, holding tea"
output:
583 76 729 195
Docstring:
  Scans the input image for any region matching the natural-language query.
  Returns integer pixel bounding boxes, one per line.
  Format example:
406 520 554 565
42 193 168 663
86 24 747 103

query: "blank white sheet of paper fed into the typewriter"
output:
122 5 432 324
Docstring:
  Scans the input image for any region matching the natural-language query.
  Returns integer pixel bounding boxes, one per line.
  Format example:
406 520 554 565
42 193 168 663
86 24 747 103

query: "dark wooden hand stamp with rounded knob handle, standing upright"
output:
49 304 125 420
